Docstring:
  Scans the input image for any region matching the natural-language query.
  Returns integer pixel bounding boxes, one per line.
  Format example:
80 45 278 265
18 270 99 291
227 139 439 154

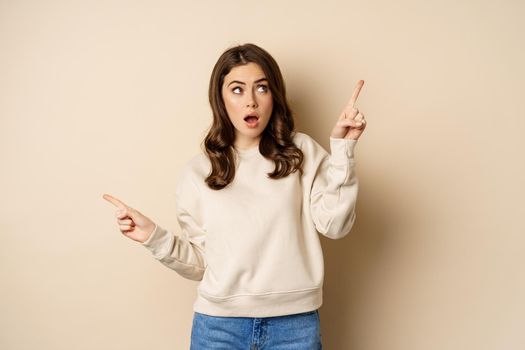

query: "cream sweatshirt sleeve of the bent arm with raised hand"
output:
310 137 358 239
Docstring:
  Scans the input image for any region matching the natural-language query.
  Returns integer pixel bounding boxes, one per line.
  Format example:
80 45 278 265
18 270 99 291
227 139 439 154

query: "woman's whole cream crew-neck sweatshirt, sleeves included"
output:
142 132 358 317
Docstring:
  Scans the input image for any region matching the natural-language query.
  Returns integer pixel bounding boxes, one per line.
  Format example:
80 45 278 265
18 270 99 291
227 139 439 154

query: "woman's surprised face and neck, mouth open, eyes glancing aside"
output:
222 62 273 149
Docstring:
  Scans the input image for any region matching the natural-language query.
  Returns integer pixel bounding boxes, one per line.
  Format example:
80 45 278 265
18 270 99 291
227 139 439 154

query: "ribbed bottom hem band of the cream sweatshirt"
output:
193 287 323 317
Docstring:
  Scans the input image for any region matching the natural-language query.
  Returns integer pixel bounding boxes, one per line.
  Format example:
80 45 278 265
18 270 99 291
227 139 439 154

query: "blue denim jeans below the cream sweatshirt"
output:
190 310 323 350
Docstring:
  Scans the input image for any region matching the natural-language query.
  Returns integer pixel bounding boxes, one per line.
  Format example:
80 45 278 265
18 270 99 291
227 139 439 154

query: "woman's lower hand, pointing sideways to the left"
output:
102 194 156 243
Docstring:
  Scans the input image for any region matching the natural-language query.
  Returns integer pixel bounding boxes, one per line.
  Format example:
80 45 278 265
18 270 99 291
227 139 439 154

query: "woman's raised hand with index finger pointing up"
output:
330 80 366 140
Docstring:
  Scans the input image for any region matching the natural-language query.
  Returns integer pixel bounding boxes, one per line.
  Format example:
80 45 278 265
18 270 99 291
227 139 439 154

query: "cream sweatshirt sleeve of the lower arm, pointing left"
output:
142 167 207 281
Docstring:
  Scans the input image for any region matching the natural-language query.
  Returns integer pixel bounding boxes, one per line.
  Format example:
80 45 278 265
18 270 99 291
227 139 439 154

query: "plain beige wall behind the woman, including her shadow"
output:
0 0 525 350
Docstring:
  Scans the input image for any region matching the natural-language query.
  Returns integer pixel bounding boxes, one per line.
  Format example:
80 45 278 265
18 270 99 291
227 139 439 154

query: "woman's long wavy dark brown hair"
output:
203 43 304 190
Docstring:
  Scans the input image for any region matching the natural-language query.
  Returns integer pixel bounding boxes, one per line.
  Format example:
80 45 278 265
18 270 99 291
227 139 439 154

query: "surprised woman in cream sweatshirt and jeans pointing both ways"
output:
104 44 366 350
